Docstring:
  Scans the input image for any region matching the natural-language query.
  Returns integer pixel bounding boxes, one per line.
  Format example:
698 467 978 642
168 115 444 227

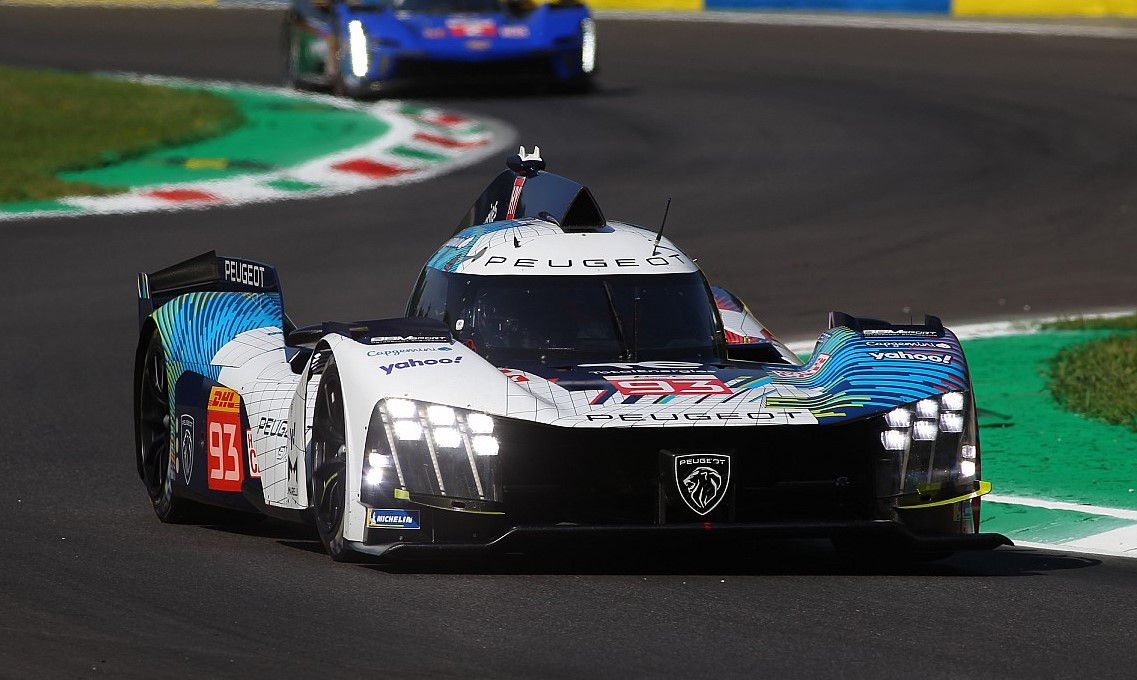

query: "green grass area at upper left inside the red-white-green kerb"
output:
0 67 242 202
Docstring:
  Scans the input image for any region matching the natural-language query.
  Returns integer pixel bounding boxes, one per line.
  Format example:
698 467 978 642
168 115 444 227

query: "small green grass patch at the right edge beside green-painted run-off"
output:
1047 315 1137 431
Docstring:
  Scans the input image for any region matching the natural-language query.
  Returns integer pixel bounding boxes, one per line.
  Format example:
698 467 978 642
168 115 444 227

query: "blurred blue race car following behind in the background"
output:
283 0 596 97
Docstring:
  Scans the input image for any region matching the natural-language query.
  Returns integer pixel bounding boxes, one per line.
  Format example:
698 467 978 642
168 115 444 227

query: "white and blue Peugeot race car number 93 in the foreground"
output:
135 150 1010 561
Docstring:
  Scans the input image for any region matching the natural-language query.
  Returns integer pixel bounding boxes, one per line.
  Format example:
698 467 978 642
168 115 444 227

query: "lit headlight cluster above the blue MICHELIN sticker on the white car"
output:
363 399 500 500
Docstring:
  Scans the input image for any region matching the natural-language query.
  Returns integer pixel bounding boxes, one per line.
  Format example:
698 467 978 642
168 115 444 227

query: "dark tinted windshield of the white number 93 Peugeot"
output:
409 269 724 364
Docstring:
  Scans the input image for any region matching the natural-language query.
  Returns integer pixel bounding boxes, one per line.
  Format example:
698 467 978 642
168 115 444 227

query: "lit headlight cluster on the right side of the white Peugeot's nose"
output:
880 392 979 495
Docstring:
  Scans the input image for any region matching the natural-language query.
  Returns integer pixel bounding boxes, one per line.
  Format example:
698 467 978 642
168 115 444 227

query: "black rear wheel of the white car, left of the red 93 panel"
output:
138 331 197 522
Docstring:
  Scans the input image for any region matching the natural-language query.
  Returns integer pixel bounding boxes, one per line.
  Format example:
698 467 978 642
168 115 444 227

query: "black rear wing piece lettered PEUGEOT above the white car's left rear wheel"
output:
138 250 283 327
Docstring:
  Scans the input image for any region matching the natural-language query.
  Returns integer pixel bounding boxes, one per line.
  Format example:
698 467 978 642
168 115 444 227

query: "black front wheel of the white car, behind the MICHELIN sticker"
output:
312 363 359 562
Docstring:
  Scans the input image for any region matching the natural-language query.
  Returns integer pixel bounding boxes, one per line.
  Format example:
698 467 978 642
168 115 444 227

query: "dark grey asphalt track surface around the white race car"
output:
0 7 1137 679
